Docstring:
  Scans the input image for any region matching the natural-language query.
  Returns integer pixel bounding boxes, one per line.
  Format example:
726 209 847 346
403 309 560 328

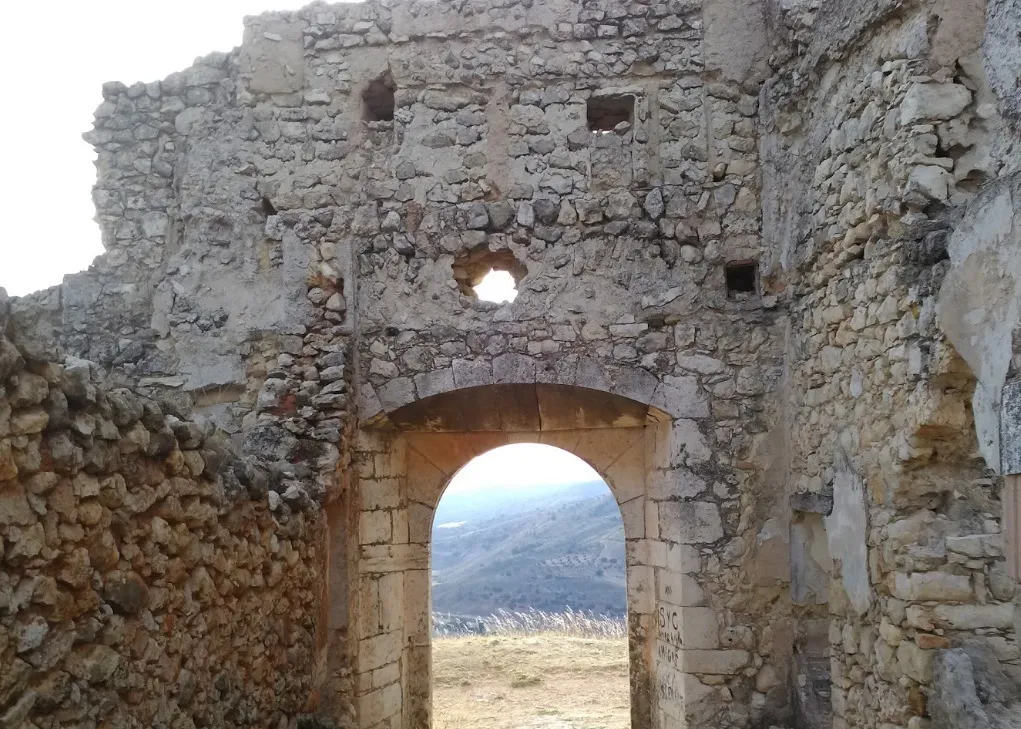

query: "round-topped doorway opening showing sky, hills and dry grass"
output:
431 443 631 729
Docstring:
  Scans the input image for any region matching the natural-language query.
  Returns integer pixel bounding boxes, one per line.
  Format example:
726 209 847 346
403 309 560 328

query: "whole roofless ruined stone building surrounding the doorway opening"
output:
0 0 1021 729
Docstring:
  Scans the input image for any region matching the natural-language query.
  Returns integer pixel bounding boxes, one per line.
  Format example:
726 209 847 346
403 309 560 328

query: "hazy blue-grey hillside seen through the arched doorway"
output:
433 482 626 616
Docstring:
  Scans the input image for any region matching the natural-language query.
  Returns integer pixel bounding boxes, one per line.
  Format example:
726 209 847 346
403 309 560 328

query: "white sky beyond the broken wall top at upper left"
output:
0 0 307 295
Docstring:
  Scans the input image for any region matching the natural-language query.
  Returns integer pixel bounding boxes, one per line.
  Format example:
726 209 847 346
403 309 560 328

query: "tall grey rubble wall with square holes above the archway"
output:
15 2 789 725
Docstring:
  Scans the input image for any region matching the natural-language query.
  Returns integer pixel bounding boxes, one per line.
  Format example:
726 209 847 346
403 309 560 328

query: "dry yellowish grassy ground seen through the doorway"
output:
433 635 630 729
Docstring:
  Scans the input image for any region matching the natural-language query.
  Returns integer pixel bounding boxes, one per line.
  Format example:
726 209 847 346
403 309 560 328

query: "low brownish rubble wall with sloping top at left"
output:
0 289 324 728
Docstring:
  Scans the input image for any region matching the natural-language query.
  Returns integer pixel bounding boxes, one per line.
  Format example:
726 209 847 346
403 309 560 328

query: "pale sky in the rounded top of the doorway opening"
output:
444 443 602 493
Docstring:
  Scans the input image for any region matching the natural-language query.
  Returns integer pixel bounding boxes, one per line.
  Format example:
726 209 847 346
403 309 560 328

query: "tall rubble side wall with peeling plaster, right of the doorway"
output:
764 3 1021 727
